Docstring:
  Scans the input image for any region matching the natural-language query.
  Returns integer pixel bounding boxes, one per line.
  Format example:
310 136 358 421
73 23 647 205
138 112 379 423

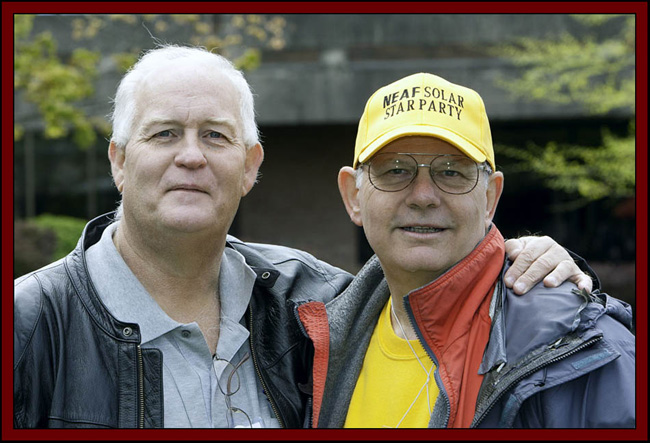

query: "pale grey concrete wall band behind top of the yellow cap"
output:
249 14 596 124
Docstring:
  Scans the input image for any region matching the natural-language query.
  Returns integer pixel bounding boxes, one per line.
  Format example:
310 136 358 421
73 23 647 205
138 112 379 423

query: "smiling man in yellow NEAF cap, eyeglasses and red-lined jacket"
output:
299 74 635 428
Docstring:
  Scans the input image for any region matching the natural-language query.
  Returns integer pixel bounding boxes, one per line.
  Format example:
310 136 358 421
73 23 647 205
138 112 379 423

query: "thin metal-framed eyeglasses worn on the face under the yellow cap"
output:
362 152 485 194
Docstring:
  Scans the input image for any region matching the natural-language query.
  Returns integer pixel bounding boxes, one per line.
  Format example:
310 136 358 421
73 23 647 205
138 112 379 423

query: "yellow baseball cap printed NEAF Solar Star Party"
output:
354 73 496 170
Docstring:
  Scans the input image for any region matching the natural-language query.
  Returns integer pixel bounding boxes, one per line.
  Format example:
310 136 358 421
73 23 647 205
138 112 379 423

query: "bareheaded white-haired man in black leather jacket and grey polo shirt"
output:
14 46 590 428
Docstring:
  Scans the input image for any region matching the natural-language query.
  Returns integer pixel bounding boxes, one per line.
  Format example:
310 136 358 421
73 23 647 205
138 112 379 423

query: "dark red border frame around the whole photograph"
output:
1 2 648 441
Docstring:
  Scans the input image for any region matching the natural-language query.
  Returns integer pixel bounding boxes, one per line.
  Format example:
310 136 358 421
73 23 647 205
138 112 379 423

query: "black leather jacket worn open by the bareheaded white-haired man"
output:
14 214 352 428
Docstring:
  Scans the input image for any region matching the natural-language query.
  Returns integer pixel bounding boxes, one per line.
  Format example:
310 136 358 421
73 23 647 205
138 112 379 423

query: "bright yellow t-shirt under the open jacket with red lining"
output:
344 299 439 428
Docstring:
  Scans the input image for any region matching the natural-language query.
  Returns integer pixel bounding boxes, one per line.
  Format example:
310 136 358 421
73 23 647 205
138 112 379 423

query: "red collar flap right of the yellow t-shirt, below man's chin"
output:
405 226 505 427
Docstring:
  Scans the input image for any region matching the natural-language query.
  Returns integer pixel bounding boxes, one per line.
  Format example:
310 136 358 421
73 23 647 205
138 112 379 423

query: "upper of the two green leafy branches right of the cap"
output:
494 14 635 114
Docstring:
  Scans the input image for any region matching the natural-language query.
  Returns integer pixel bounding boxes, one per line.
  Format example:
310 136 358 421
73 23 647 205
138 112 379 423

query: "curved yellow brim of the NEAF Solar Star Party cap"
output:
354 125 487 168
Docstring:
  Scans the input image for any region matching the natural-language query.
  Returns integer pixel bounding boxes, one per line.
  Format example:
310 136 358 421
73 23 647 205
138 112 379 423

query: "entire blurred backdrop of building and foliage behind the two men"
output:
14 14 636 324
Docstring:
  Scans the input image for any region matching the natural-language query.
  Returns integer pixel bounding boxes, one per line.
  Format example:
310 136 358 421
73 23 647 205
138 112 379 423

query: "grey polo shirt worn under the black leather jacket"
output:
86 222 279 428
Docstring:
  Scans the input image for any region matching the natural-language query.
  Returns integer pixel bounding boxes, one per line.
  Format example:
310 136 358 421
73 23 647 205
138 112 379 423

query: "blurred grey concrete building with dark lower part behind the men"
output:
14 14 636 306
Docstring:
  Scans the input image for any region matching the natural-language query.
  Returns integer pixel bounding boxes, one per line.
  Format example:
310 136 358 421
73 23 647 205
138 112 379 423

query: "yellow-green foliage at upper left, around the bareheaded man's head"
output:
14 14 285 148
